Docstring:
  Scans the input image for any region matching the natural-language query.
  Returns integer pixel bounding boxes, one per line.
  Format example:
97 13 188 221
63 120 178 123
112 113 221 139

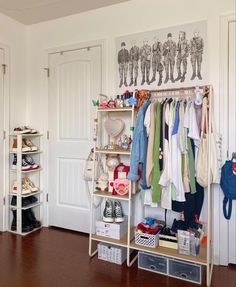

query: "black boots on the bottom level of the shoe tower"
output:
11 208 41 232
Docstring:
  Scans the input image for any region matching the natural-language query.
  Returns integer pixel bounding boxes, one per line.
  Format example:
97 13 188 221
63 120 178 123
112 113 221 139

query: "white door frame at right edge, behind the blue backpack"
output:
218 14 236 265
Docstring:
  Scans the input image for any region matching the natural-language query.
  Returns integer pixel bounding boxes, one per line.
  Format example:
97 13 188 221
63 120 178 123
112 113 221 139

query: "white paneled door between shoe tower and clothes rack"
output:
48 46 102 233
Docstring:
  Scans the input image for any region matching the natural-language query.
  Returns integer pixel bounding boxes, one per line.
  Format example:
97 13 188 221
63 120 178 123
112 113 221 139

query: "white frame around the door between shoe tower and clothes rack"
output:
40 39 107 227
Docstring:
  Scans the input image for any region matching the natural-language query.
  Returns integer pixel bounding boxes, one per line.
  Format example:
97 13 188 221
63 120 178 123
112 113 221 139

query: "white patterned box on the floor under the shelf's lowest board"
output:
98 242 127 265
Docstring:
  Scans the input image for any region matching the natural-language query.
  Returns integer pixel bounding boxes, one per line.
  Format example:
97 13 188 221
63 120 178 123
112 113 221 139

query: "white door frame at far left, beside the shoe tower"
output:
0 43 10 231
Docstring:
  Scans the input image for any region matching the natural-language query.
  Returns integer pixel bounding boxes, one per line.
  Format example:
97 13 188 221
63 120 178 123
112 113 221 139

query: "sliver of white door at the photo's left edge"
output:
0 49 5 231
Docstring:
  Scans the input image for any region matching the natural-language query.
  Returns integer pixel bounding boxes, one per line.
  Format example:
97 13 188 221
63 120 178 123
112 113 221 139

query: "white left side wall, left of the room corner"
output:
0 11 26 128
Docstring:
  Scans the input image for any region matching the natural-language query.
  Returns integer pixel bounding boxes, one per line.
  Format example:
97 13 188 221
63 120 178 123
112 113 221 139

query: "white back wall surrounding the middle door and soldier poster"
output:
27 0 235 262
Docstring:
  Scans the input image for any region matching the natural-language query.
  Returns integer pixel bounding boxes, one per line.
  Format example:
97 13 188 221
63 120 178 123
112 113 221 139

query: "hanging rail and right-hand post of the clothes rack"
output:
150 85 213 286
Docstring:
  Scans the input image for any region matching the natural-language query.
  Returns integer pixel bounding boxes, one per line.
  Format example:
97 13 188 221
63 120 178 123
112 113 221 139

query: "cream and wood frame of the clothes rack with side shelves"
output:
89 85 213 286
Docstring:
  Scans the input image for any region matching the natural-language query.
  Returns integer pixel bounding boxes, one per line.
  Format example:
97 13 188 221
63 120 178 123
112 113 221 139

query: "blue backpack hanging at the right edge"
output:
220 160 236 220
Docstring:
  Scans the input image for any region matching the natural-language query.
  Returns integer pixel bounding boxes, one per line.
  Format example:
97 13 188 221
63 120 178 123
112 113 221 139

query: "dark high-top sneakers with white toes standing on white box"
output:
103 199 125 223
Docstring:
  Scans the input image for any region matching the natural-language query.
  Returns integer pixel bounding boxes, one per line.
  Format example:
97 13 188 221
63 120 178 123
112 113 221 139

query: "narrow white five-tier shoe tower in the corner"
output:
8 133 43 236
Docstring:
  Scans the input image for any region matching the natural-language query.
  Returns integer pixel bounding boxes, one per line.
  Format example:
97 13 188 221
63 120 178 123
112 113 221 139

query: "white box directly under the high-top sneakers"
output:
96 216 128 240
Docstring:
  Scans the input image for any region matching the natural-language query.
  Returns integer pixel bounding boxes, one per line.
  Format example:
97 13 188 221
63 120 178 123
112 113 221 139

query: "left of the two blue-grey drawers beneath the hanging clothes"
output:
138 251 167 275
